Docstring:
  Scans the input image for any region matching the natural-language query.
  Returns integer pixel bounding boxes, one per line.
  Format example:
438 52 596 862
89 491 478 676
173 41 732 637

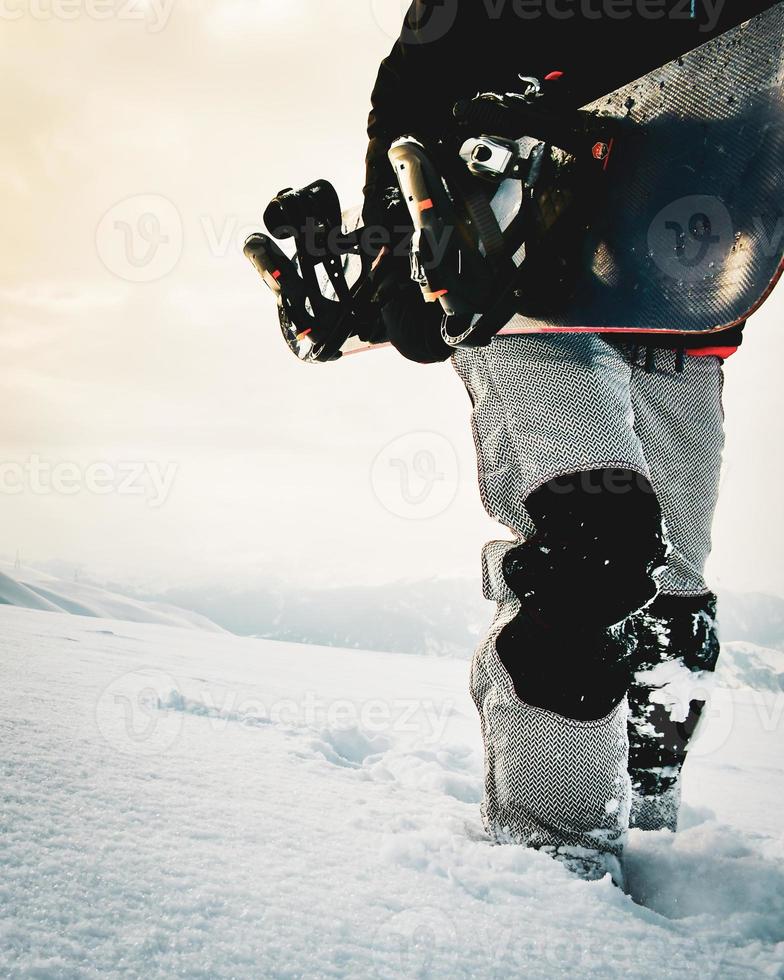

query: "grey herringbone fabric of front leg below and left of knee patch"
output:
471 542 631 879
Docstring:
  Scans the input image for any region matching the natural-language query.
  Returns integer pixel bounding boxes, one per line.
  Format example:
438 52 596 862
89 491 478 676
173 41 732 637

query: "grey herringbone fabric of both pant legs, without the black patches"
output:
453 334 724 854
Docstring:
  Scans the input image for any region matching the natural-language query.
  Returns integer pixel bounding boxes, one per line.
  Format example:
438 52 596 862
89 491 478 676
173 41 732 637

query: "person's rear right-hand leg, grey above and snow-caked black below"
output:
628 351 724 831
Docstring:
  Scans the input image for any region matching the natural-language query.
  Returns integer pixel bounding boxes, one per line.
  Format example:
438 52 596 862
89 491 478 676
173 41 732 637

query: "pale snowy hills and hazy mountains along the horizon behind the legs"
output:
0 562 784 693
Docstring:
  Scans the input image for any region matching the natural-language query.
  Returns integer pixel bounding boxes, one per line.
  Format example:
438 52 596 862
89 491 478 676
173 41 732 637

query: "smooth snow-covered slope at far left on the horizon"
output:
0 561 222 632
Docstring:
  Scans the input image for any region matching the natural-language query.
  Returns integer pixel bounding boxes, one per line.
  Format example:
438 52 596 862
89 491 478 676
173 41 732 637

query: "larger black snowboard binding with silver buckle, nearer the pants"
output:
389 78 615 347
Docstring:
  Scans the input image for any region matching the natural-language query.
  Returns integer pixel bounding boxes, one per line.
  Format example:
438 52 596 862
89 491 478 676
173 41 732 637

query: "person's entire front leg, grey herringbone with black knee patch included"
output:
454 335 664 870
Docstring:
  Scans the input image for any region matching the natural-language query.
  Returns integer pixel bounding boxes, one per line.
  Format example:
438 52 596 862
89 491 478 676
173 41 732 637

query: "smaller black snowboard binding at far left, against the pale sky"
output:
244 180 385 363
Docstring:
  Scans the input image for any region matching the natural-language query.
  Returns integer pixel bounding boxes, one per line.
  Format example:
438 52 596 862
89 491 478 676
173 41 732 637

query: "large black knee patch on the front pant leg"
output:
496 469 667 719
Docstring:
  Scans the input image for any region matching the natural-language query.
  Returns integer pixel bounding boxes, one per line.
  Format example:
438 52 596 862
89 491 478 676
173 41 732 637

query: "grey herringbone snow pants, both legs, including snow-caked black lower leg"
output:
453 334 724 855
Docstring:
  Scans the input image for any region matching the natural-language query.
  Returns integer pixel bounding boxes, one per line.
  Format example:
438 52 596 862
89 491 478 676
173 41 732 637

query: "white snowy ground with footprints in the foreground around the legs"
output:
0 607 784 980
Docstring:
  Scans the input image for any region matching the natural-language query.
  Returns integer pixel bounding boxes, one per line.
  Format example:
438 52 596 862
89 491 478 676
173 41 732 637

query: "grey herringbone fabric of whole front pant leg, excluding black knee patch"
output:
453 334 648 868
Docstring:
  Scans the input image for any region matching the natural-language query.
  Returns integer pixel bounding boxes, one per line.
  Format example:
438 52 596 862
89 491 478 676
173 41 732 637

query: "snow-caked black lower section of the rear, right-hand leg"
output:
629 594 719 832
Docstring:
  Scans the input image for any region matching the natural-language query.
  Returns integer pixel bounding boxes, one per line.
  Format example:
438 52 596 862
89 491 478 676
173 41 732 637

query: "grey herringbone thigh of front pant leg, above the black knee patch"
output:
452 334 648 540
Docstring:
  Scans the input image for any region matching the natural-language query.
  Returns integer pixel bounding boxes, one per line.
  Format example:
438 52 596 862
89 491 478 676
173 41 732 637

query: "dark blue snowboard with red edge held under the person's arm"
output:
245 3 784 362
